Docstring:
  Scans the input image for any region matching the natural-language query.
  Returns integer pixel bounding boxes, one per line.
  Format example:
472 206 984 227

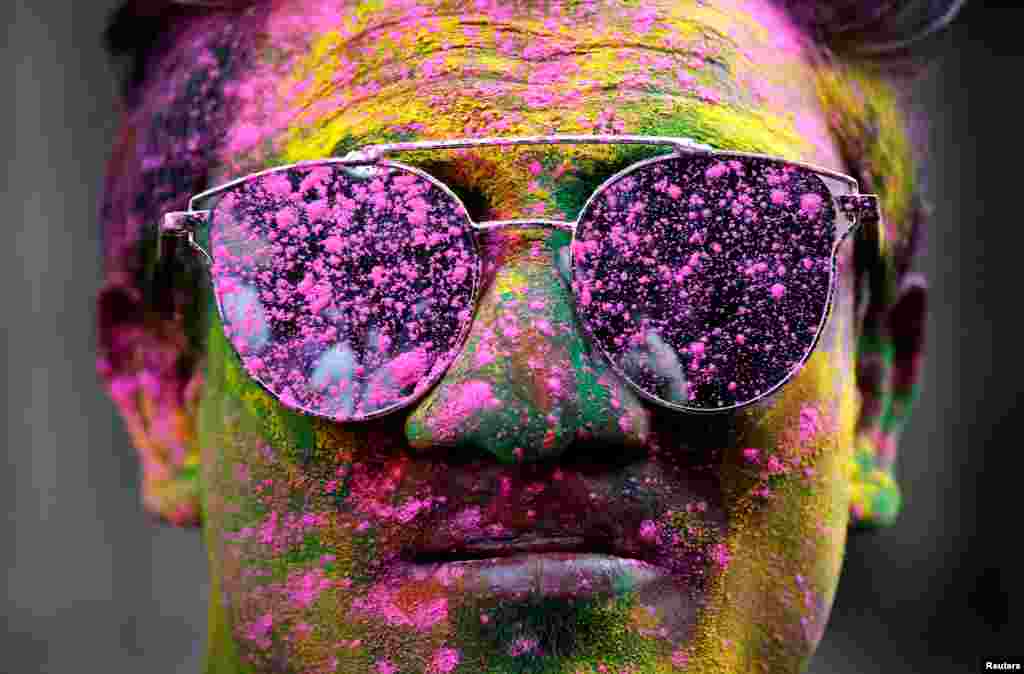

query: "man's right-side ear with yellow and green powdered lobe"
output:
850 275 927 528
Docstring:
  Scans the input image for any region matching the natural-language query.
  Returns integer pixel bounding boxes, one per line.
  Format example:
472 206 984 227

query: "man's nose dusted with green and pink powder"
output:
406 226 649 463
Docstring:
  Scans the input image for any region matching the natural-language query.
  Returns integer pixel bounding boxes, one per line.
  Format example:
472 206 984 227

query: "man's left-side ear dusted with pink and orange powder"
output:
97 282 202 526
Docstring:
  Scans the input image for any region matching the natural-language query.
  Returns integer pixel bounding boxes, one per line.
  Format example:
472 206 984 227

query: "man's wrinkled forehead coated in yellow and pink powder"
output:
205 0 842 177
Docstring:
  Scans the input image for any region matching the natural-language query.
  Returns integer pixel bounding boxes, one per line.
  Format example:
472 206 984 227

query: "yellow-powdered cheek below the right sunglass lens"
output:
684 297 857 659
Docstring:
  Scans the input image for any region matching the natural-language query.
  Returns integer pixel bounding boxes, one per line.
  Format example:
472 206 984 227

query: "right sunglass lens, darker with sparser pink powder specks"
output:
572 157 835 411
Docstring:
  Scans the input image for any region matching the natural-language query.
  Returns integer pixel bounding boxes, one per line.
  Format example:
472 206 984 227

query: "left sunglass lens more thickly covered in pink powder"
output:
211 164 478 421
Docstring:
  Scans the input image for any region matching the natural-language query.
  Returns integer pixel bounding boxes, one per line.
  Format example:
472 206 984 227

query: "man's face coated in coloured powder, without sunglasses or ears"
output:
119 0 876 674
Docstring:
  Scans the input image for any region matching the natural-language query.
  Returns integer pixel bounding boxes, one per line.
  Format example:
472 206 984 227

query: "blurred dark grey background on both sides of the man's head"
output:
0 0 1024 674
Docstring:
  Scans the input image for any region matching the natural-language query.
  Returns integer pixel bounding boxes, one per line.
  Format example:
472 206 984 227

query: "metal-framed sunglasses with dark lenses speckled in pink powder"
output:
160 135 880 422
